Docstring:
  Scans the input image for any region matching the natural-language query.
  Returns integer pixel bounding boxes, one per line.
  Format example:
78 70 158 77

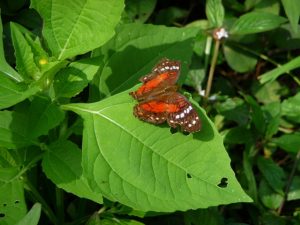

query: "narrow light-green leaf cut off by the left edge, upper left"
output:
0 15 24 82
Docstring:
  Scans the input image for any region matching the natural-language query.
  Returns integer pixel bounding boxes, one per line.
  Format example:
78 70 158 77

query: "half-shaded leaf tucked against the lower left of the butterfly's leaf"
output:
42 141 102 204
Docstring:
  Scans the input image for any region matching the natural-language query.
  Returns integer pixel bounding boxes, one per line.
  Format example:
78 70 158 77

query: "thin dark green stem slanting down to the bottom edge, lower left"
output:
24 179 59 225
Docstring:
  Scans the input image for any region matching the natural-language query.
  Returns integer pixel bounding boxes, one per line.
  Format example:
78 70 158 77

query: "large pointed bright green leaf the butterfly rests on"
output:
63 91 251 212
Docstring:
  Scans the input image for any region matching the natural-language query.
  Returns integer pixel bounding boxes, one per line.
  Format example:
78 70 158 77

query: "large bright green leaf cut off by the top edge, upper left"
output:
31 0 124 60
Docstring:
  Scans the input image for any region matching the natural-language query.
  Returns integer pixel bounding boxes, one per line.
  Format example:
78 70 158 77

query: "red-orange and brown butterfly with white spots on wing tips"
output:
129 58 201 133
